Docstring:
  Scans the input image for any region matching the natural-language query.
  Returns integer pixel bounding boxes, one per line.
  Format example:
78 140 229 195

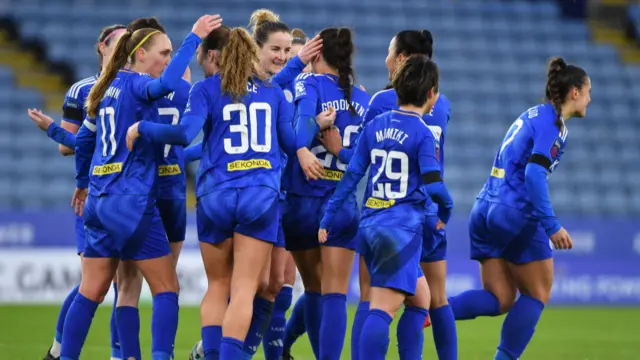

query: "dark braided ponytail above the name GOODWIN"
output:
319 28 357 113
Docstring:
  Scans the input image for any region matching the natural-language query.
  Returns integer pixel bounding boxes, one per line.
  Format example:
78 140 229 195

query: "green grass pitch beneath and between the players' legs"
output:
0 306 640 360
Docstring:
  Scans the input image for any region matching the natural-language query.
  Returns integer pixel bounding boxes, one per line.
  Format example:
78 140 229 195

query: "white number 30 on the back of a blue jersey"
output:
222 102 271 154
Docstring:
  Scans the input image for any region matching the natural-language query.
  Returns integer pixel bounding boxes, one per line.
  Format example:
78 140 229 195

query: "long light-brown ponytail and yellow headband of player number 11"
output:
86 20 168 117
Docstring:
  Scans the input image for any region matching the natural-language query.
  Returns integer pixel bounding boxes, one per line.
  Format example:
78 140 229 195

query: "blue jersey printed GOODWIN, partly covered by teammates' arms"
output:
288 73 371 197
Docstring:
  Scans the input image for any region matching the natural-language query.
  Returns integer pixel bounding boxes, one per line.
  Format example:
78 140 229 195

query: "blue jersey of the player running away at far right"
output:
478 104 567 212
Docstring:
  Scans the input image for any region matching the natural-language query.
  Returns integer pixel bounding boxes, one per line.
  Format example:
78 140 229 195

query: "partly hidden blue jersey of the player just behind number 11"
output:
157 80 191 192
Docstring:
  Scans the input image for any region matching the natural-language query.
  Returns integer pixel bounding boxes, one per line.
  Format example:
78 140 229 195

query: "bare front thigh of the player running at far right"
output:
509 258 553 304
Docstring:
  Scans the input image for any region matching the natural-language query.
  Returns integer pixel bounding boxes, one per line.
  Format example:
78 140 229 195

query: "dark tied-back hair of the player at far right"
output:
545 57 587 131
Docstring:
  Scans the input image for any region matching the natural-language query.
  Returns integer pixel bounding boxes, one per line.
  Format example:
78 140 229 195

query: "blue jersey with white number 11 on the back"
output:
85 70 163 195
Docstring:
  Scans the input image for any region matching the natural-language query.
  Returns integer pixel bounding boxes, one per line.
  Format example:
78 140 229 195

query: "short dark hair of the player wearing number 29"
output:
391 54 439 106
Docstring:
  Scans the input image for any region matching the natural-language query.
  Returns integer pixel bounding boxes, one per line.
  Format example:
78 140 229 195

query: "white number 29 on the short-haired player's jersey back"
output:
371 149 409 199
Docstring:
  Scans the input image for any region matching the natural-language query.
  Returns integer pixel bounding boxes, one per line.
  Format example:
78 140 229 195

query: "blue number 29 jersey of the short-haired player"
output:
358 110 435 229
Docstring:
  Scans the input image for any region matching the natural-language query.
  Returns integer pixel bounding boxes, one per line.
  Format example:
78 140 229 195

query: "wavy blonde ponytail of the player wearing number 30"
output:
220 27 266 102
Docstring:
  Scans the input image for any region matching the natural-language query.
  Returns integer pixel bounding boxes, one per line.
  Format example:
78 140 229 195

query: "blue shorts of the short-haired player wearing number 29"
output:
359 226 422 301
